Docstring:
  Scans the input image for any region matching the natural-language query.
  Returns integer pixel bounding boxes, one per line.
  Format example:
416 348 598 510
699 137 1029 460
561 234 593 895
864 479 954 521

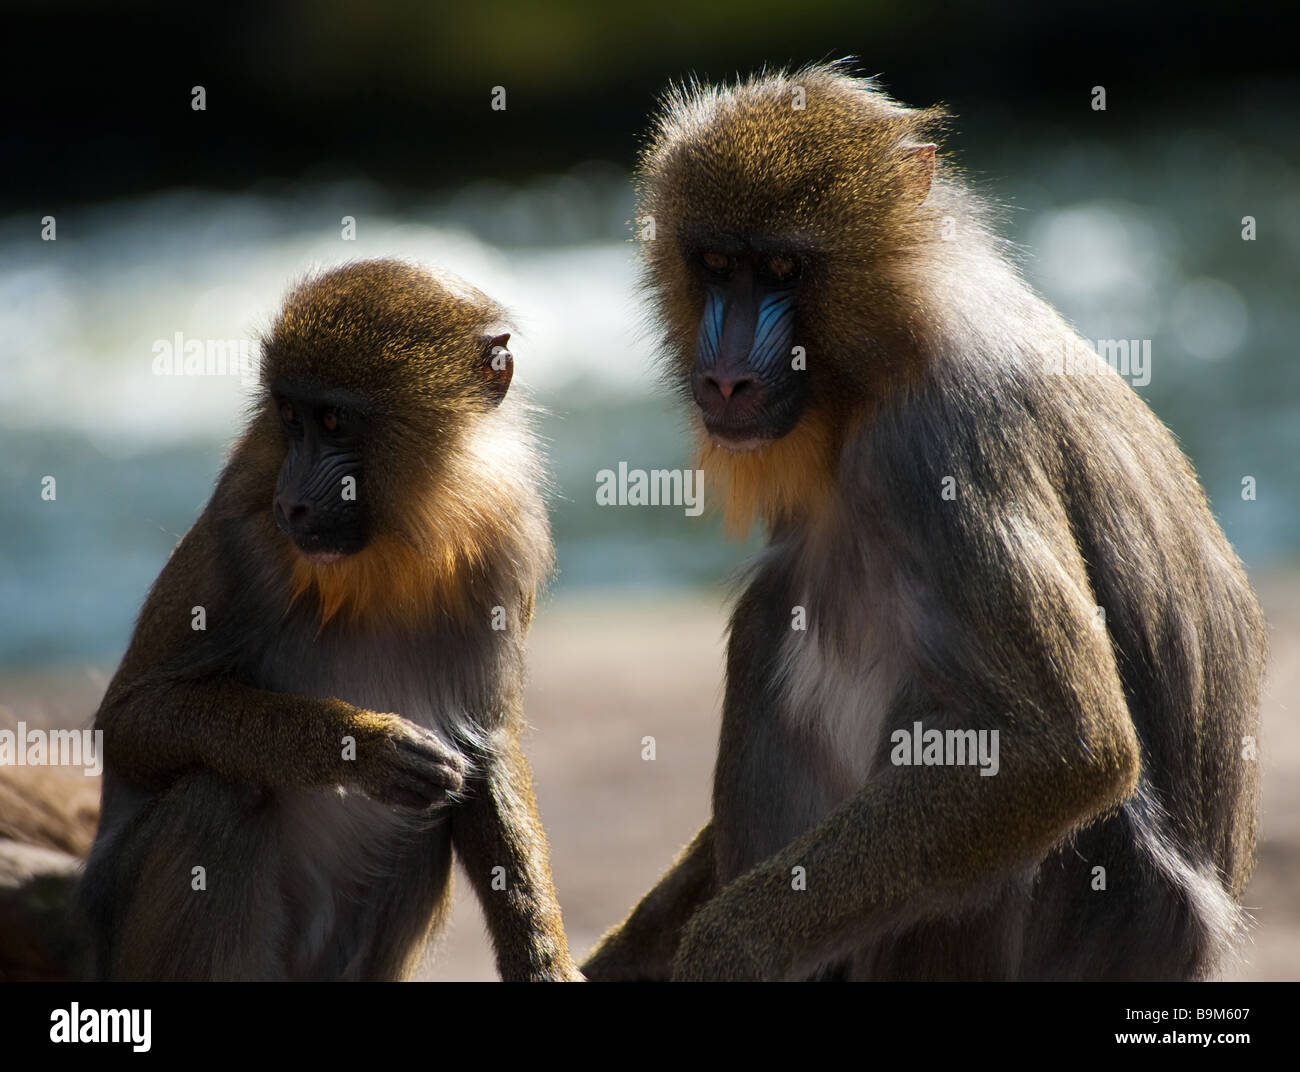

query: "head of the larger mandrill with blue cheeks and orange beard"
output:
637 68 943 472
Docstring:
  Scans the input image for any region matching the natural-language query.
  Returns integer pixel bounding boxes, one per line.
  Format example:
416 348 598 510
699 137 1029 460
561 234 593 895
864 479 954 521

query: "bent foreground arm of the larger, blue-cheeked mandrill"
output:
673 481 1139 980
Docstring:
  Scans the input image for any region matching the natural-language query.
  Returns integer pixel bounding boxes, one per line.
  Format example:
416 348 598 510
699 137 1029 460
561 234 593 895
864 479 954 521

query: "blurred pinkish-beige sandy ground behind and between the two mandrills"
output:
0 577 1300 980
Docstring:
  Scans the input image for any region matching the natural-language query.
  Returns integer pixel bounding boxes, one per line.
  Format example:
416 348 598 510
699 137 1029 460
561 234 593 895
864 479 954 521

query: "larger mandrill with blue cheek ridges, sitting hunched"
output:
585 66 1265 980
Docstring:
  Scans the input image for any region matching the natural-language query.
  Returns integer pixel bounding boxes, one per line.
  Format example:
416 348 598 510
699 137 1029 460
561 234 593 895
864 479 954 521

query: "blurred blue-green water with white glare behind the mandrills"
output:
0 2 1300 667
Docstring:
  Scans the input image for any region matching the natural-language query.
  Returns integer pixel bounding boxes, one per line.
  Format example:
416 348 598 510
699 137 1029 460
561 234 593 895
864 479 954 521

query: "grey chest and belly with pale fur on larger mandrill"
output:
714 535 906 878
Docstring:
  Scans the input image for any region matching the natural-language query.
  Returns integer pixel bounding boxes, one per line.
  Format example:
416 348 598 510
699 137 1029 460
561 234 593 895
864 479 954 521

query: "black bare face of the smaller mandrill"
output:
273 382 369 563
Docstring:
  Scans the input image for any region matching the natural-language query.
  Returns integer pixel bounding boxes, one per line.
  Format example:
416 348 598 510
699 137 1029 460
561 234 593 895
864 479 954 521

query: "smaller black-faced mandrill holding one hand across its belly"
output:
83 260 581 980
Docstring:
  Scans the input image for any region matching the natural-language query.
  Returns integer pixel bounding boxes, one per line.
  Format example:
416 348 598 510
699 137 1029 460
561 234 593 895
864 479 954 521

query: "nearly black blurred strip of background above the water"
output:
0 0 1296 209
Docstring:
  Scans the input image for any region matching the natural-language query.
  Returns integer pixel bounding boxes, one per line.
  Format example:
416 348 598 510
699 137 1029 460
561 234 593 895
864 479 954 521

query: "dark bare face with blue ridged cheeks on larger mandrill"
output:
685 234 807 450
